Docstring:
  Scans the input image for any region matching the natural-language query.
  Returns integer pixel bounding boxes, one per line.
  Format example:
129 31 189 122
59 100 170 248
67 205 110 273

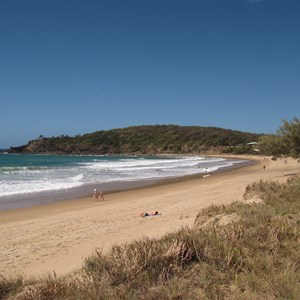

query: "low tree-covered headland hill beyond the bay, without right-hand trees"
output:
9 125 261 154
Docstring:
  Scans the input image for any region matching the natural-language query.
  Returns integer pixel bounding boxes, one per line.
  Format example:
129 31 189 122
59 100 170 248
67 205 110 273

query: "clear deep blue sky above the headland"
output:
0 0 300 148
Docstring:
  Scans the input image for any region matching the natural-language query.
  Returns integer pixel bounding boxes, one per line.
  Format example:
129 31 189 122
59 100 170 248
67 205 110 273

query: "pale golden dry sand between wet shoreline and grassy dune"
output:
0 157 300 278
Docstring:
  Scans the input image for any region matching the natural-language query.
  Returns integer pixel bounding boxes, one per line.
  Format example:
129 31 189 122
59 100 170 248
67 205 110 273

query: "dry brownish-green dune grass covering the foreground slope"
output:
0 177 300 300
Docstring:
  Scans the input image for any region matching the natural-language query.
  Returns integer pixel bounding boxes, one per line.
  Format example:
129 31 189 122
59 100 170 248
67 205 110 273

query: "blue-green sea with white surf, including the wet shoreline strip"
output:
0 154 245 210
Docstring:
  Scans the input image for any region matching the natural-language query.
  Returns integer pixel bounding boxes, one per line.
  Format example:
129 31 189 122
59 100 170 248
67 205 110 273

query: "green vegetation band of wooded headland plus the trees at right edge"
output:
7 118 300 158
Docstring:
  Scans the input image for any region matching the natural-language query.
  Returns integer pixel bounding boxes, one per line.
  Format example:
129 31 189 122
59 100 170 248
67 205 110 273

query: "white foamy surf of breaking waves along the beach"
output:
0 157 246 197
